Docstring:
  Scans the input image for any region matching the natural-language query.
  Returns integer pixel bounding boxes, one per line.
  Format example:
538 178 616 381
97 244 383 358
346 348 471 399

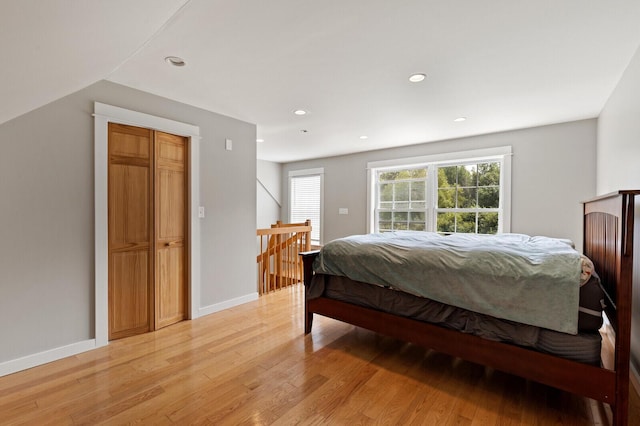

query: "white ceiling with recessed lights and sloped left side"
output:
0 0 640 162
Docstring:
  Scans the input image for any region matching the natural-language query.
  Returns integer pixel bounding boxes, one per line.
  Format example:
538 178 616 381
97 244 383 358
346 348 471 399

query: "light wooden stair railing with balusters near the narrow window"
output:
256 220 311 294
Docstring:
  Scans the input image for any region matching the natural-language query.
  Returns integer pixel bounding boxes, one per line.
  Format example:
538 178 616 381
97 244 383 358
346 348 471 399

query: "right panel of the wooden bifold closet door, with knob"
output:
155 132 187 329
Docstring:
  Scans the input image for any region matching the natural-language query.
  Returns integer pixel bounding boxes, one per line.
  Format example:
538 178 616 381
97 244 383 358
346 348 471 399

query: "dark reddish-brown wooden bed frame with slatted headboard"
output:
301 190 640 426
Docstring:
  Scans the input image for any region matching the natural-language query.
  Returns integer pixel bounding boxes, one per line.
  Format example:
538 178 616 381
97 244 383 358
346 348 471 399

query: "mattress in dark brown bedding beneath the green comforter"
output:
306 274 602 365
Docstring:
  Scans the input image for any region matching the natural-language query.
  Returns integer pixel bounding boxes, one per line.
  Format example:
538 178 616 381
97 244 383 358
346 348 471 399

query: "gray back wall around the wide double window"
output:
282 119 596 249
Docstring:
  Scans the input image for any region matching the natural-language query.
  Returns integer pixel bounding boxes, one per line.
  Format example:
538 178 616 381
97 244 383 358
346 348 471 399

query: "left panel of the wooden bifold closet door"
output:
108 124 154 339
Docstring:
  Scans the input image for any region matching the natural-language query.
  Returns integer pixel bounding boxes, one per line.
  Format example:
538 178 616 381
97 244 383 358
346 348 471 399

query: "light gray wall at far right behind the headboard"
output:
597 42 640 372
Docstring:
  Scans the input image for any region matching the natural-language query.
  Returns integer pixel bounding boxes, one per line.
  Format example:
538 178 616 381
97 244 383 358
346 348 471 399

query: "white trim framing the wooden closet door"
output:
93 102 200 347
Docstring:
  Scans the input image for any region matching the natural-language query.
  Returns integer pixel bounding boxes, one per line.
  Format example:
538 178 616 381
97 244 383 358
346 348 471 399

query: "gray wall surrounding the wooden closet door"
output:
0 81 256 362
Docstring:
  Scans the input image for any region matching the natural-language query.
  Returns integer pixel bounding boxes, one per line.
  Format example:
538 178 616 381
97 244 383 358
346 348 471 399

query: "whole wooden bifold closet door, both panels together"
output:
108 124 187 340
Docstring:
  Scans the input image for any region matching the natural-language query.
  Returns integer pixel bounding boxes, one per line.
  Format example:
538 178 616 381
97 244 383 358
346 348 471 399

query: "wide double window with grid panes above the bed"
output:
369 147 511 234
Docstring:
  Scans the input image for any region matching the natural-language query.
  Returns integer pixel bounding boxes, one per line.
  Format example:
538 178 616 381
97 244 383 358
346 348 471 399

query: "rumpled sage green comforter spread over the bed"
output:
314 231 581 334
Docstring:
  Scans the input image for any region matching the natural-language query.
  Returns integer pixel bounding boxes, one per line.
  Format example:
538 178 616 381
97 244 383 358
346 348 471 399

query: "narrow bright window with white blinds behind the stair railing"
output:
289 168 324 245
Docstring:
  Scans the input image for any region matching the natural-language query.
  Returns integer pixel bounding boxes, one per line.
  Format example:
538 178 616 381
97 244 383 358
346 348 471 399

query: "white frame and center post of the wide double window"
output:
367 146 512 233
